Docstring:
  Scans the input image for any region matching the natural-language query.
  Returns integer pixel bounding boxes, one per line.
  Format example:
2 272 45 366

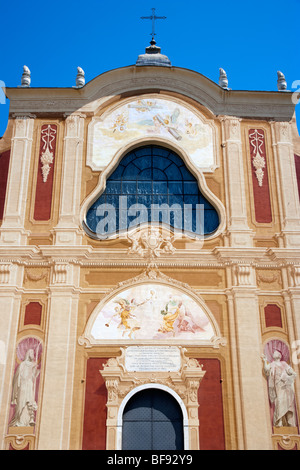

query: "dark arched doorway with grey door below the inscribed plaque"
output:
122 388 184 450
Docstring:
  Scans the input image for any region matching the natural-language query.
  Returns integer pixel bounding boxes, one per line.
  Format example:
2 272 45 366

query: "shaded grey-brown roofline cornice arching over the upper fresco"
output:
6 65 295 120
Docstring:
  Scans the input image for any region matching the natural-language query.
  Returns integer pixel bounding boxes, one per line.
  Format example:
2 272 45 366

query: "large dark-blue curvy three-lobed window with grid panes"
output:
85 145 220 239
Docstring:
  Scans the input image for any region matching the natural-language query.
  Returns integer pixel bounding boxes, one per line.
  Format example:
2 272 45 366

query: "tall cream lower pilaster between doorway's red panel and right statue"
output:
231 264 272 450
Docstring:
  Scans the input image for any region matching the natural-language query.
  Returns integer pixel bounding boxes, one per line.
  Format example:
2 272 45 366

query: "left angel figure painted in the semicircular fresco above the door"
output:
105 298 148 338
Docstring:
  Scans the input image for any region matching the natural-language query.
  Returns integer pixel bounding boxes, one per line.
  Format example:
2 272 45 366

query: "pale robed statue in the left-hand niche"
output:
9 349 40 426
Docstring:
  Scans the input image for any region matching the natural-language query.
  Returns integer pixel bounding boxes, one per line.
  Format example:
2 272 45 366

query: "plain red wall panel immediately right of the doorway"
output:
198 359 225 450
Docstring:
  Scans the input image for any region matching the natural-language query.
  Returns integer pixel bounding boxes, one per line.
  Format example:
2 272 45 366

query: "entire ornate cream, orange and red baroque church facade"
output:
0 45 300 450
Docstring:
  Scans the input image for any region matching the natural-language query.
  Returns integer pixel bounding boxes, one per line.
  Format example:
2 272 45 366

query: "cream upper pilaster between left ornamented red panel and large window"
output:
54 113 85 246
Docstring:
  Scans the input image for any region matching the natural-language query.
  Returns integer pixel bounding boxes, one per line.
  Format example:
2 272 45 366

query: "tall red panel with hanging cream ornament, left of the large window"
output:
33 124 57 221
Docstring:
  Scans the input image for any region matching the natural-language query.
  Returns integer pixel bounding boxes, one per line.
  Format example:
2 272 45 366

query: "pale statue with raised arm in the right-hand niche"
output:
262 351 297 427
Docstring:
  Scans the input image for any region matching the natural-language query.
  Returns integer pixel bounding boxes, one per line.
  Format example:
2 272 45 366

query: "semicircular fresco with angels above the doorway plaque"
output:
91 284 215 340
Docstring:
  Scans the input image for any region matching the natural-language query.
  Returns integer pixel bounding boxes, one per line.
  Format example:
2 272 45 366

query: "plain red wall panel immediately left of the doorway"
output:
82 358 107 450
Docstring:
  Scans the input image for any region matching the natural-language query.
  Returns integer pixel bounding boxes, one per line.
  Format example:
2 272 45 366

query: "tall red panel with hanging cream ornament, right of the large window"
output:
249 129 272 223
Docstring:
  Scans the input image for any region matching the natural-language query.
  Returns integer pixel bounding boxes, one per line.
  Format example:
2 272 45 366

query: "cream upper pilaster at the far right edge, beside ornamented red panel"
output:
271 122 300 247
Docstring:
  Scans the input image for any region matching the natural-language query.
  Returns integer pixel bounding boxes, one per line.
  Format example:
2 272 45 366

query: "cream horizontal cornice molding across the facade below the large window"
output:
0 245 300 269
